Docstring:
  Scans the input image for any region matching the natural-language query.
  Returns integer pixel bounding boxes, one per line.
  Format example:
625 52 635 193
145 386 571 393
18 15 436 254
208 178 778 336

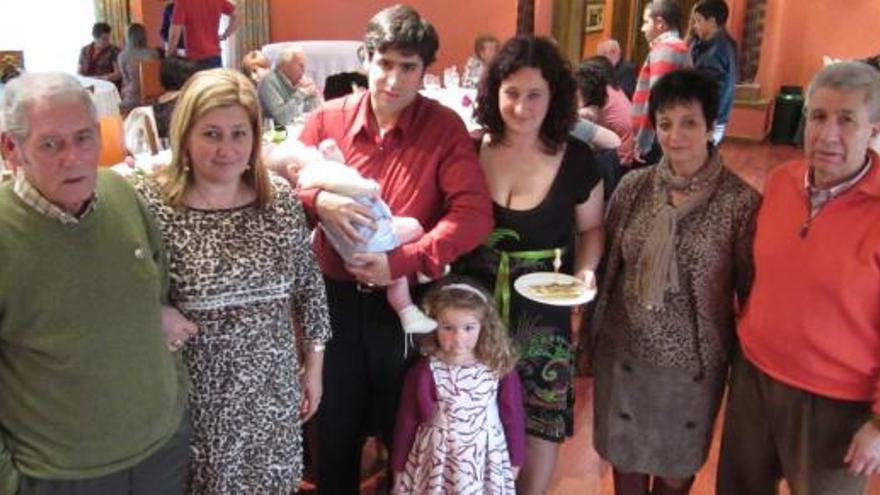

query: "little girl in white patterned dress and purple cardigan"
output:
391 282 525 495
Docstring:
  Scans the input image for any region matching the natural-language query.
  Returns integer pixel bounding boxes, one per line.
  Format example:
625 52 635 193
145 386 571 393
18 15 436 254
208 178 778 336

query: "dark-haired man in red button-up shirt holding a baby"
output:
300 5 492 494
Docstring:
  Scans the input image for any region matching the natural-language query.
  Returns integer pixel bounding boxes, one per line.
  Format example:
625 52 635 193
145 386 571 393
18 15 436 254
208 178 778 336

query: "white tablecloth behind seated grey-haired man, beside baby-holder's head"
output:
262 40 361 89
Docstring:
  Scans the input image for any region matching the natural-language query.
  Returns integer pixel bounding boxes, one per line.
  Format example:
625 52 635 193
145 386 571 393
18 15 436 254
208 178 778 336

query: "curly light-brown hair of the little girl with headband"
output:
420 278 518 377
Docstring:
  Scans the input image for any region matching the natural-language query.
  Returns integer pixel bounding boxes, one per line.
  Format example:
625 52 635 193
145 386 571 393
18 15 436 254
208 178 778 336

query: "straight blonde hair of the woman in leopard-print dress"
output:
160 69 273 208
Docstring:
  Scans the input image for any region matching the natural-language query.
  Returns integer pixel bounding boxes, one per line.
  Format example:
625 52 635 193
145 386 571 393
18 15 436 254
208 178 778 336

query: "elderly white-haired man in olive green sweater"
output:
0 73 195 495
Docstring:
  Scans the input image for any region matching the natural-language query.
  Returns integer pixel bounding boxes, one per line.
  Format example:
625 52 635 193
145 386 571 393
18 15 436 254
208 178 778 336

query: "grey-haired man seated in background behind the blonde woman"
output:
257 47 321 125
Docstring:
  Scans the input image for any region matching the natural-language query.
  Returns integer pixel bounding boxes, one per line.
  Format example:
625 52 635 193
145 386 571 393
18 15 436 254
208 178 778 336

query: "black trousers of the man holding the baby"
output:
318 277 417 495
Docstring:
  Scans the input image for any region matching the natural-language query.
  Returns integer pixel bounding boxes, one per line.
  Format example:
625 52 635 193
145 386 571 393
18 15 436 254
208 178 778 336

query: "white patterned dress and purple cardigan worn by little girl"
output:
391 357 525 495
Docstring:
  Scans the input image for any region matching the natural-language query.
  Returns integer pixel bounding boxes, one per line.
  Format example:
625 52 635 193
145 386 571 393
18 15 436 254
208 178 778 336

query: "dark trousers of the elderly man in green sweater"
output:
18 413 192 495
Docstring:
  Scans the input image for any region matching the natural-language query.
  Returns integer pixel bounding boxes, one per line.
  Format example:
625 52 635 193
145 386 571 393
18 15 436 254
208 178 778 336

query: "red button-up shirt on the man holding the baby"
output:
299 92 493 280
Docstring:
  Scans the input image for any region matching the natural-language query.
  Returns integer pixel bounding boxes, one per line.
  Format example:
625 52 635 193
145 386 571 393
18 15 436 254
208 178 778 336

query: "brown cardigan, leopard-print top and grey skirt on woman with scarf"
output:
591 161 760 478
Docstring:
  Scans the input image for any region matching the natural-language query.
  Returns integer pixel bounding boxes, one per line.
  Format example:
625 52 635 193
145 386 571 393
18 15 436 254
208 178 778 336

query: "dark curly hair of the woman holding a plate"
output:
475 36 577 153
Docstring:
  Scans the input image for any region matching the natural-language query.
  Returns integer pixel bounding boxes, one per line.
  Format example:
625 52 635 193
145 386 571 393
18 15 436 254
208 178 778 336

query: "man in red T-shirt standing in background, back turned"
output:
165 0 238 69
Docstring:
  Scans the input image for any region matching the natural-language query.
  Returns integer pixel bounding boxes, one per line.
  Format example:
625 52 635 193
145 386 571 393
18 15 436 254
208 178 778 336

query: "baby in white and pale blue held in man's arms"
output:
265 139 437 336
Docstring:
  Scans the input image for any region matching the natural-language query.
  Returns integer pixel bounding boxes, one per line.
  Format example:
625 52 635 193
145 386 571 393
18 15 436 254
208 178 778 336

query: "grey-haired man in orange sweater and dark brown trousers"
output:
717 62 880 495
